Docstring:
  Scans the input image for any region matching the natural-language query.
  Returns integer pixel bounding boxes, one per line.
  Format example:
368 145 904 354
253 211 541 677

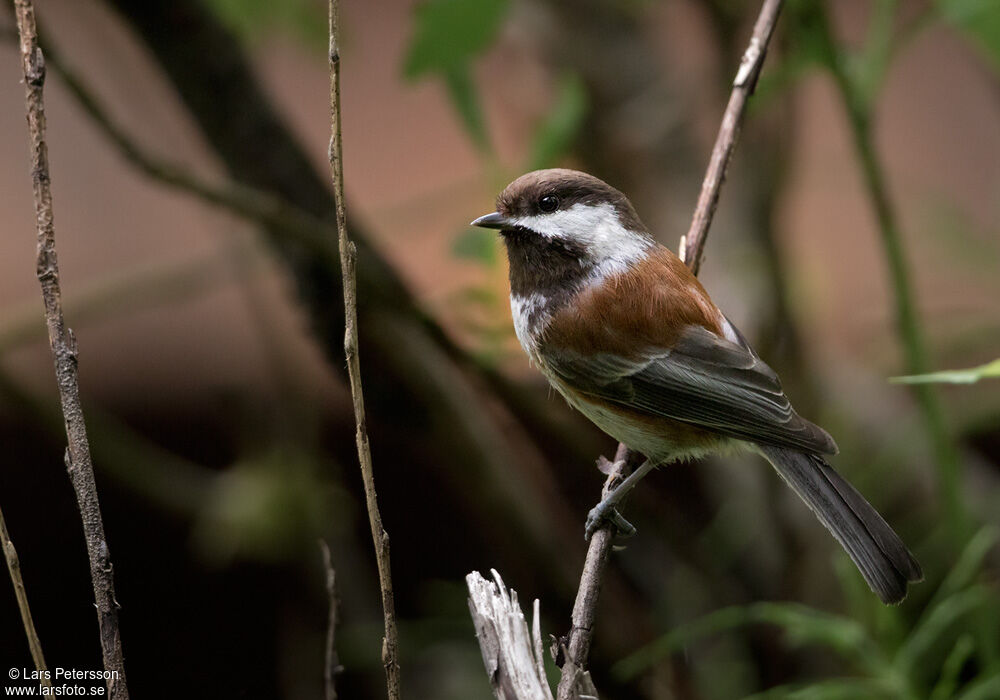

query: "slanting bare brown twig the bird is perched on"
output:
557 0 782 700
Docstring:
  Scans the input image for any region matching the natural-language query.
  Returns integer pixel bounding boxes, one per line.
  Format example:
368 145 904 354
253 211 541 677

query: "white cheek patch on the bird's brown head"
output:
514 202 653 279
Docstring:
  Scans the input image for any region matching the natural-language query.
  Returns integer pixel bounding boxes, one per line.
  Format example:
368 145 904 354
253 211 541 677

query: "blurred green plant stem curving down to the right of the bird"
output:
817 7 969 541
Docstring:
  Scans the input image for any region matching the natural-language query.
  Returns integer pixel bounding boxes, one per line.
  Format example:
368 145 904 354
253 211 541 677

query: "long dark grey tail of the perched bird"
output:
758 445 924 604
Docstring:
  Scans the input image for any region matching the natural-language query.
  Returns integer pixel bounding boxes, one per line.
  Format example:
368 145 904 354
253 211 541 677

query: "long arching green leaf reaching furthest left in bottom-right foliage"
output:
611 603 880 681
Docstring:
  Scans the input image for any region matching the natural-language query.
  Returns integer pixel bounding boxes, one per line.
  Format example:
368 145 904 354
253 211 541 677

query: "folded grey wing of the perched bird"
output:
546 326 837 454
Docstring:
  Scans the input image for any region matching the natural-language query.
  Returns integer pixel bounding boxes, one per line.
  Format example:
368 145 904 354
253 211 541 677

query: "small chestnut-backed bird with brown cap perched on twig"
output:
472 169 923 604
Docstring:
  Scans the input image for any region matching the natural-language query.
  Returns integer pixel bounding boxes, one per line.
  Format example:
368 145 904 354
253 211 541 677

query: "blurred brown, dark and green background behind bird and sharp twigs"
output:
0 0 1000 700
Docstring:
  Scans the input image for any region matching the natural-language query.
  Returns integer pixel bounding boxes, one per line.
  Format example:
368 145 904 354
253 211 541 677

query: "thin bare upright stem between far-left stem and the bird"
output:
329 0 400 700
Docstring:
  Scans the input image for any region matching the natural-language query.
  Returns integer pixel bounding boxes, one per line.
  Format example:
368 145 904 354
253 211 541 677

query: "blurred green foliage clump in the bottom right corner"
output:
612 527 1000 700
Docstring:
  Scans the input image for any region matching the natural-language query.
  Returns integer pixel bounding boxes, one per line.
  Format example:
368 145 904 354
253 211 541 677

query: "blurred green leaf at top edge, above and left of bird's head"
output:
404 0 508 79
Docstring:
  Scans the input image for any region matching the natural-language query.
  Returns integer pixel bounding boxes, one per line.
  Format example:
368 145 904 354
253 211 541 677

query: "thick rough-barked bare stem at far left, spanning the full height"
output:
15 0 128 700
